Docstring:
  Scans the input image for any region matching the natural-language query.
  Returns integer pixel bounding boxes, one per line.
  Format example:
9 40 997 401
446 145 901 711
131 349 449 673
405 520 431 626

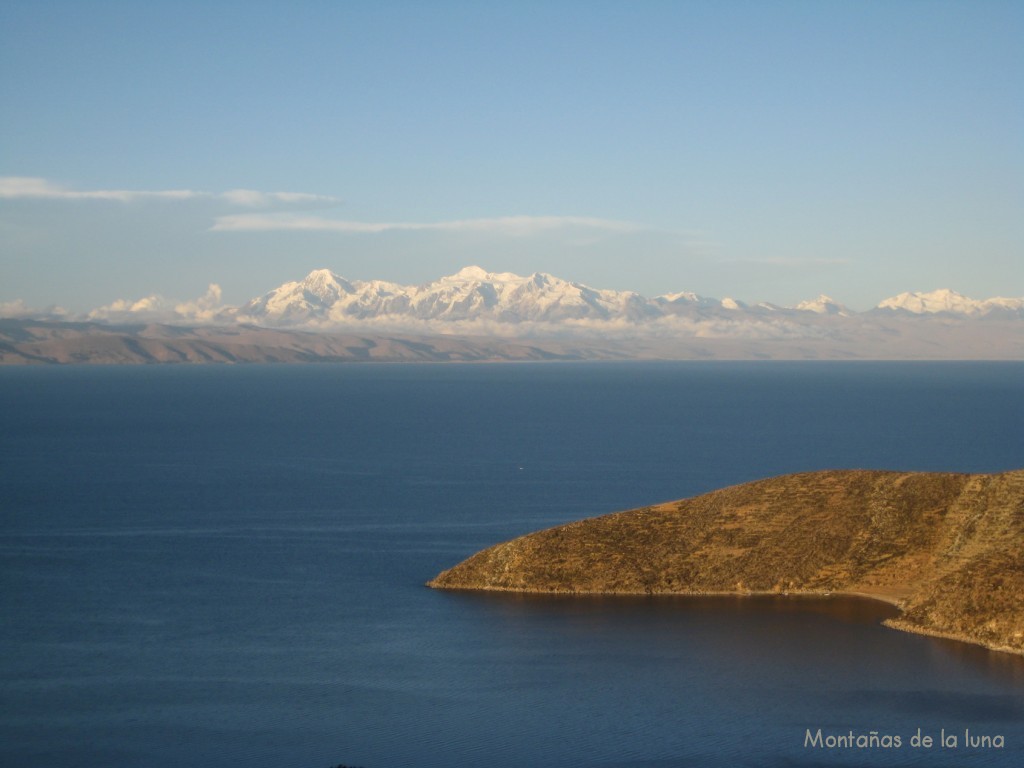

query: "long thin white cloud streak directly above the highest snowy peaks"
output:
212 213 639 236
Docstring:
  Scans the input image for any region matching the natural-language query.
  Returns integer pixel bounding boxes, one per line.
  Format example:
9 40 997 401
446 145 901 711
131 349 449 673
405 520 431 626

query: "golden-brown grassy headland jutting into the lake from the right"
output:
429 470 1024 652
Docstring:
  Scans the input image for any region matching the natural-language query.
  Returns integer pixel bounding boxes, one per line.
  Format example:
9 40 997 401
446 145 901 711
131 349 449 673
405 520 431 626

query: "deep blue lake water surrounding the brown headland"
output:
0 362 1024 768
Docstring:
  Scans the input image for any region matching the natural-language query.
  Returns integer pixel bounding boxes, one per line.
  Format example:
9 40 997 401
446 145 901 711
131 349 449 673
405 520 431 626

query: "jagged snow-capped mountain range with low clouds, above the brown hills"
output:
9 266 1024 331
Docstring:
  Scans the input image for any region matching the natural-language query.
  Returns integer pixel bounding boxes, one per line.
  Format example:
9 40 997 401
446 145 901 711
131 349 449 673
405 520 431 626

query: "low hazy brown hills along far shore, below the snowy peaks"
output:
0 318 1024 366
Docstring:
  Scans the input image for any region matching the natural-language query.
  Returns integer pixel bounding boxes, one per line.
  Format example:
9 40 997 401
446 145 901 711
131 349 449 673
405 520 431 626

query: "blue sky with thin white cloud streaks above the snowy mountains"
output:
0 0 1024 311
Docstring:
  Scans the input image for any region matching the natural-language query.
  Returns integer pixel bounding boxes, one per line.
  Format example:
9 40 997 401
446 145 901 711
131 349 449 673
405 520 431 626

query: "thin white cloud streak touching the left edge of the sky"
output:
0 176 341 208
